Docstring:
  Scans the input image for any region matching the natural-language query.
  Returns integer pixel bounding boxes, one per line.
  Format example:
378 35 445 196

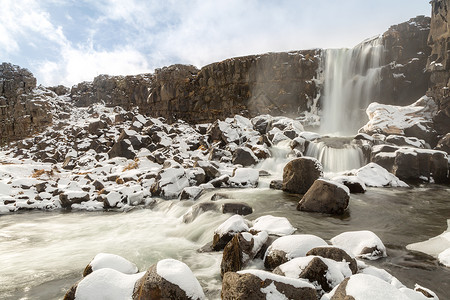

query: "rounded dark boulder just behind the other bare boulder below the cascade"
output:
283 157 322 194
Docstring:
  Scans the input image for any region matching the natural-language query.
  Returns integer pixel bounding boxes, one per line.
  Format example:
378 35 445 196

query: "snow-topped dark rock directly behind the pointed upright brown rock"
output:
212 215 249 251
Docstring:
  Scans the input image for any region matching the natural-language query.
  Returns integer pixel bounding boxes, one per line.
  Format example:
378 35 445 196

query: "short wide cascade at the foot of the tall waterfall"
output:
305 137 365 173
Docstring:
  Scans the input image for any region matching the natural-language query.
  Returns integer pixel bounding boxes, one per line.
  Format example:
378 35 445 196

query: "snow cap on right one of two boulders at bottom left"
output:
156 259 206 299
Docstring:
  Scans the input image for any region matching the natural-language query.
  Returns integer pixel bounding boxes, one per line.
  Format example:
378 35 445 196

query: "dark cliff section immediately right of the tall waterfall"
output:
378 16 431 105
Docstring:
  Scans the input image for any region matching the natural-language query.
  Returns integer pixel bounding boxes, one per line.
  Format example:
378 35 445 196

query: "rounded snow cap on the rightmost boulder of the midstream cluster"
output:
330 230 387 260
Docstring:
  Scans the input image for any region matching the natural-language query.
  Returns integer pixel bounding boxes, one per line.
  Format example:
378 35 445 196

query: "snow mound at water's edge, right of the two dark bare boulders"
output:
350 162 408 187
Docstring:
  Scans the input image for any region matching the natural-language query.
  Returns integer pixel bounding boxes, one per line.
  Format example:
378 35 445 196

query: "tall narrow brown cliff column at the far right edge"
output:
427 0 450 135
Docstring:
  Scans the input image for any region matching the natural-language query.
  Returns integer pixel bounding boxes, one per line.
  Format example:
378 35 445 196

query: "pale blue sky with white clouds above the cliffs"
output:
0 0 431 87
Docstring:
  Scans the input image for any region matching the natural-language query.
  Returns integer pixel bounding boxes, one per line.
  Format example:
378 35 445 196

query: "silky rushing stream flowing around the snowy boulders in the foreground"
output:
0 186 450 299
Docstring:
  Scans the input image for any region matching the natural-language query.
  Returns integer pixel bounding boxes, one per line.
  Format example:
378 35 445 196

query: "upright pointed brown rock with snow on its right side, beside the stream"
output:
220 231 269 277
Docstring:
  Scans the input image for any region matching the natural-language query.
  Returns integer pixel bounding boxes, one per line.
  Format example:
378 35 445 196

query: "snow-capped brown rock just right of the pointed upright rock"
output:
264 234 328 270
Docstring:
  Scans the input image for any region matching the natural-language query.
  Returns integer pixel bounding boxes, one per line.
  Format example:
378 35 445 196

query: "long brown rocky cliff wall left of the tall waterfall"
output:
71 50 319 123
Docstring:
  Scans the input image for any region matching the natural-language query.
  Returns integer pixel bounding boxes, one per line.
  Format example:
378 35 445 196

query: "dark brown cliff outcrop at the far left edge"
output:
0 63 52 145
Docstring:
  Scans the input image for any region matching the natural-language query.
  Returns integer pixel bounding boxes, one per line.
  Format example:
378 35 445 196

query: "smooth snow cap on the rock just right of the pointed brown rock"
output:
264 234 328 260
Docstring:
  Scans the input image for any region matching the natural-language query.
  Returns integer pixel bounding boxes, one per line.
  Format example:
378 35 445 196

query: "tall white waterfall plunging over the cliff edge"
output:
320 37 384 135
